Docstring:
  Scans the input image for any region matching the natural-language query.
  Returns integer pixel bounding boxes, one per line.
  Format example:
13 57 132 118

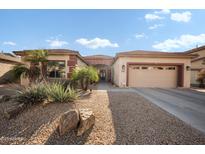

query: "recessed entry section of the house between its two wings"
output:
84 55 113 82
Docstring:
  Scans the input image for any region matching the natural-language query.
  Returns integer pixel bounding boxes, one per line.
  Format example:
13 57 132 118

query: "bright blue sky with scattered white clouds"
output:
0 10 205 56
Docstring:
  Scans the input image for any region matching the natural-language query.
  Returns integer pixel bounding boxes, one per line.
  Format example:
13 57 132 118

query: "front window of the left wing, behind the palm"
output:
47 61 65 78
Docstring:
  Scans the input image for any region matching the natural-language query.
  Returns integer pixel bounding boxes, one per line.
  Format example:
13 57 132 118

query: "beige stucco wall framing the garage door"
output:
113 57 191 87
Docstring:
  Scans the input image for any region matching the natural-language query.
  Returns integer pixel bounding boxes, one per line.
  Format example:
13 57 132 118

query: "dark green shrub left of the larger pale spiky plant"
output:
17 84 47 105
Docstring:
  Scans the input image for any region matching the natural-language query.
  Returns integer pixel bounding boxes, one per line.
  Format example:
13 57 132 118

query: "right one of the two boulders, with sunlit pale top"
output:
77 109 95 136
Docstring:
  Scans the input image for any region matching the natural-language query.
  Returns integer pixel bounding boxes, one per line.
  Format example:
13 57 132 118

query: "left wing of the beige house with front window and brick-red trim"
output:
13 49 88 83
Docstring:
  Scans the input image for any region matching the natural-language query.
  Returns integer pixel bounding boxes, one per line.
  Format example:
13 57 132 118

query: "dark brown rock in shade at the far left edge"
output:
4 103 25 119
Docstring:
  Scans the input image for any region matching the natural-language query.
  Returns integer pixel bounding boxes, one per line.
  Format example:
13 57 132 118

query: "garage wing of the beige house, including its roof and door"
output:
112 50 195 88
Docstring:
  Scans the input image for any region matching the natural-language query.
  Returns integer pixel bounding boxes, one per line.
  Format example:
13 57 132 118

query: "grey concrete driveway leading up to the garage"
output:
135 88 205 133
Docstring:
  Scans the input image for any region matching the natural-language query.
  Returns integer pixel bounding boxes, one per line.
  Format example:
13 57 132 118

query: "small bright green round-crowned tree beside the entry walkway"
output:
71 66 99 91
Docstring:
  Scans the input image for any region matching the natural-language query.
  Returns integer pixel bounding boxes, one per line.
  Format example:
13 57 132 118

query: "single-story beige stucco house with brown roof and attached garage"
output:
14 49 199 88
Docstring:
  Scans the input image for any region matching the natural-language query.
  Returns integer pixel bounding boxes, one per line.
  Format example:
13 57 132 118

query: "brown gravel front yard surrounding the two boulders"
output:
0 84 205 144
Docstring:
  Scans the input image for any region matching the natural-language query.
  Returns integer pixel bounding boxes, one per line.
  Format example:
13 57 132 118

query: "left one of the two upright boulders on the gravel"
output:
59 109 79 136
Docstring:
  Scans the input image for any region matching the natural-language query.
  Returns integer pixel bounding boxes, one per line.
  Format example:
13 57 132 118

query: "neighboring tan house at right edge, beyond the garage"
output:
186 46 205 86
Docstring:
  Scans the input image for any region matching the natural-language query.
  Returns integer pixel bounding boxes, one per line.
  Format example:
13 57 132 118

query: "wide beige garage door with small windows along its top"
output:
128 65 178 88
